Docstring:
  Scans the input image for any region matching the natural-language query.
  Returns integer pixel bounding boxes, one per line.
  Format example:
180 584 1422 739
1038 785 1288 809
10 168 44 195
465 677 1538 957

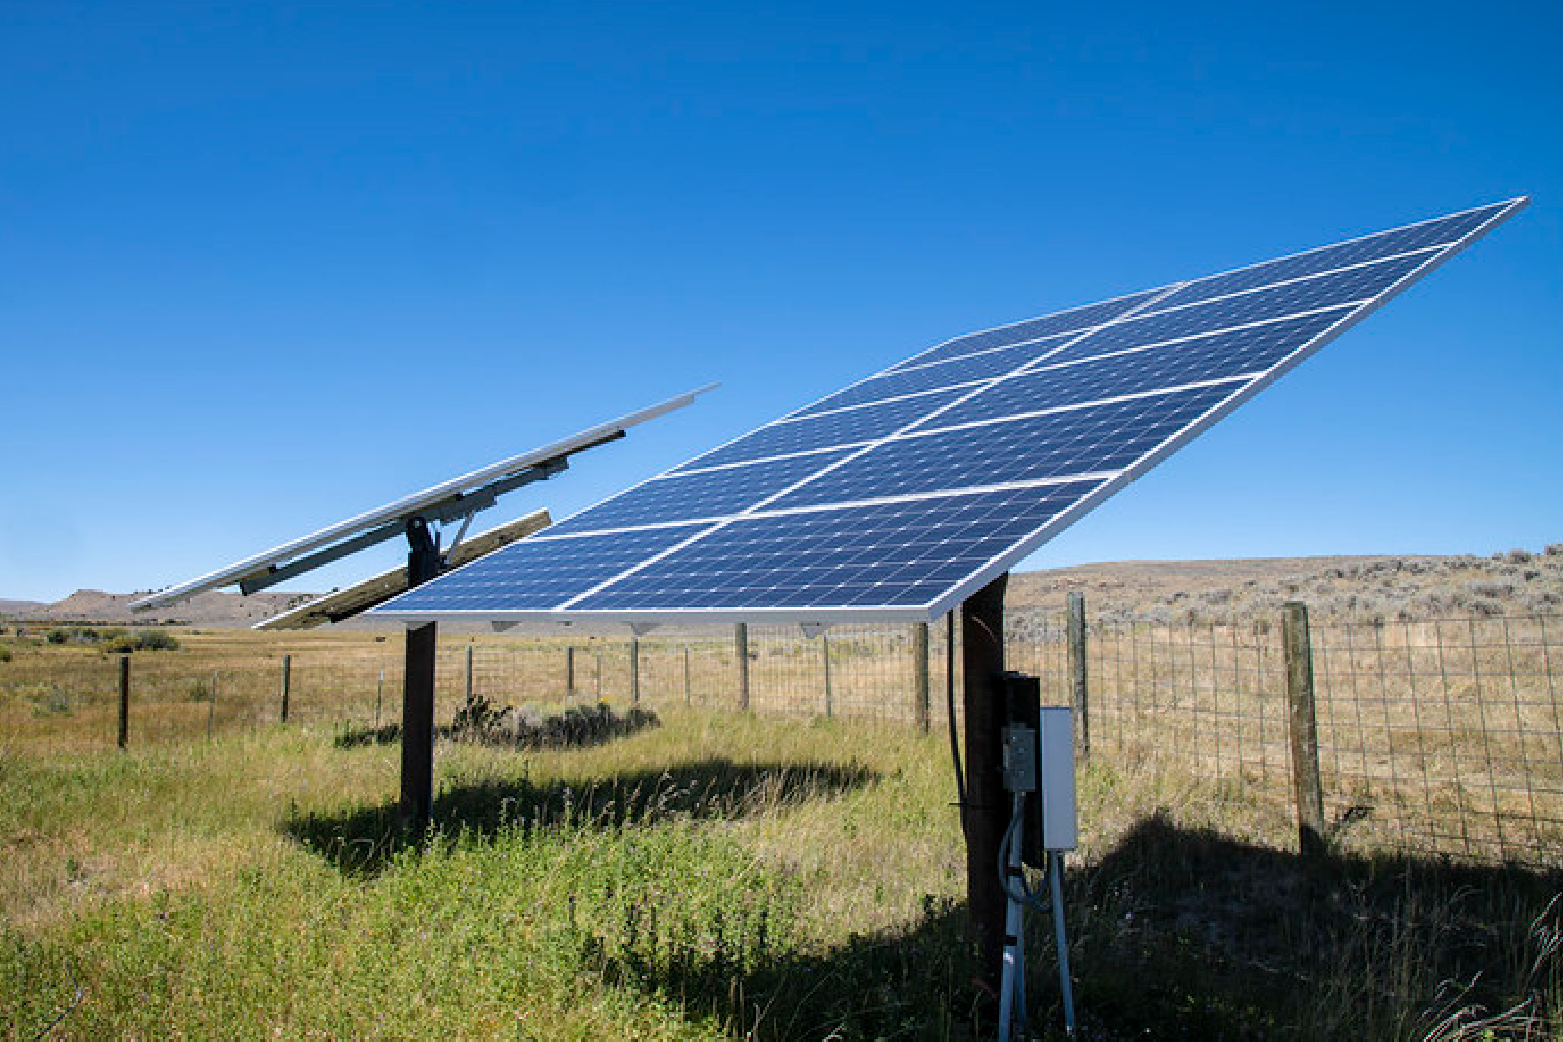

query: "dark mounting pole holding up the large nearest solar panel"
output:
961 572 1010 995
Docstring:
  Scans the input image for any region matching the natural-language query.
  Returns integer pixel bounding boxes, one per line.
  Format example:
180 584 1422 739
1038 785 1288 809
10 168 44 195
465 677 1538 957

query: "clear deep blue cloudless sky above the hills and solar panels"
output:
0 0 1563 600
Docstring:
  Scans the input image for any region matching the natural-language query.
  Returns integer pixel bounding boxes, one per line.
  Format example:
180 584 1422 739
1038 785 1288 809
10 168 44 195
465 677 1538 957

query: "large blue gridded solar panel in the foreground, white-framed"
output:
377 198 1527 622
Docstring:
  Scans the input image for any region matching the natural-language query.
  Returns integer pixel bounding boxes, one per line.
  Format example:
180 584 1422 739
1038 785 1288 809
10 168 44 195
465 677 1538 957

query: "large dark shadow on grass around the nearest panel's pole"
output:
600 815 1563 1042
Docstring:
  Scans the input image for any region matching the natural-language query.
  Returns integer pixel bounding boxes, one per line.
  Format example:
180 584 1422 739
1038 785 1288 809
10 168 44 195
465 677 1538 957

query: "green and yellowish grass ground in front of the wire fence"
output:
0 706 1563 1039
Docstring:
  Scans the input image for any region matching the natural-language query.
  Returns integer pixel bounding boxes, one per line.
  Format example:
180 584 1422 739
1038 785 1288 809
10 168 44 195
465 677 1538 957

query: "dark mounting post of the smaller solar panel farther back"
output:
400 517 439 831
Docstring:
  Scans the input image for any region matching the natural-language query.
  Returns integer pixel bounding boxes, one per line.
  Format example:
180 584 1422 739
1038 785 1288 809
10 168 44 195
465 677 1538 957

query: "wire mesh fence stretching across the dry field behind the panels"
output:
0 612 1563 867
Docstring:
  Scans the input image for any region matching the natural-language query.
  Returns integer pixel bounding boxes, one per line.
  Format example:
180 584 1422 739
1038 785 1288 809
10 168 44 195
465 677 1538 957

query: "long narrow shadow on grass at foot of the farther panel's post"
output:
283 758 880 875
